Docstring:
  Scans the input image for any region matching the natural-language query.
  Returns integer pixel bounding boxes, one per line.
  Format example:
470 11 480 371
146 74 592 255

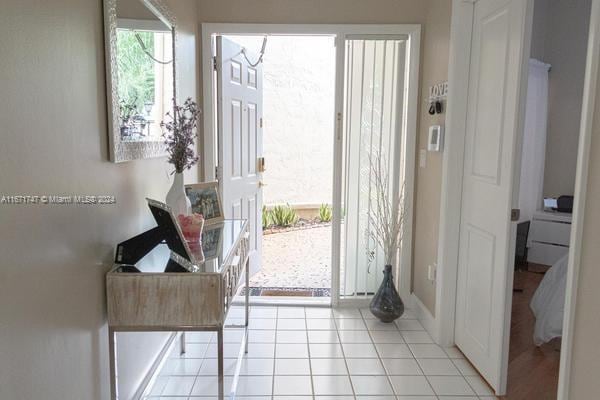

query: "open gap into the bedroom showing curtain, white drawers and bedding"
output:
507 0 591 400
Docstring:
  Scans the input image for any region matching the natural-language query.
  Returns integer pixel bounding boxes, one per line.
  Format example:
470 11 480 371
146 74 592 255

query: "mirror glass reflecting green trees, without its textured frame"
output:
116 0 174 142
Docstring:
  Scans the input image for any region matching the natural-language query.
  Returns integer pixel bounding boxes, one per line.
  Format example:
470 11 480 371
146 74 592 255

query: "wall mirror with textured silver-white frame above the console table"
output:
104 0 177 163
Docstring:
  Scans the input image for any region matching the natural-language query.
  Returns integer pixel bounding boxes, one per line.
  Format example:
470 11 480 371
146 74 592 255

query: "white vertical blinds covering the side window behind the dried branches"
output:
340 37 407 298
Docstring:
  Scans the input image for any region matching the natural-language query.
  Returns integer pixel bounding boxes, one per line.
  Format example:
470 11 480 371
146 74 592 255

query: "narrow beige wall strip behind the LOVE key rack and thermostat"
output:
413 0 452 314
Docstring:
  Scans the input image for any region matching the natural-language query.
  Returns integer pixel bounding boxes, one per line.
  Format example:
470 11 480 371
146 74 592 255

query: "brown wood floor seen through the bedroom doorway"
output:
503 267 560 400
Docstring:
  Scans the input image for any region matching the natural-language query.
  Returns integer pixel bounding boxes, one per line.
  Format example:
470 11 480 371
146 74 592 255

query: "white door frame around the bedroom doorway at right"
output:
432 0 600 400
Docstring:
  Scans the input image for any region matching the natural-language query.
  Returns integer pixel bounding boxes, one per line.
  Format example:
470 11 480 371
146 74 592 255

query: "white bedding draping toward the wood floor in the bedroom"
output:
529 254 569 346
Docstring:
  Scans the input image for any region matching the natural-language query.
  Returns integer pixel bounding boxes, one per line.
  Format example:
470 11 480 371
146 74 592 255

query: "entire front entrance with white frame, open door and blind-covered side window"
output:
202 24 420 305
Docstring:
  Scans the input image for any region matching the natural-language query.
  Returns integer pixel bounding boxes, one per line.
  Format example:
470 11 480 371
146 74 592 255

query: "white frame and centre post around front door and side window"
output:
201 23 421 306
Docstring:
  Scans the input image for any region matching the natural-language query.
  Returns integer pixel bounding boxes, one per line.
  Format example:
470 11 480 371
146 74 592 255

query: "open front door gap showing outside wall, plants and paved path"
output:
224 35 335 298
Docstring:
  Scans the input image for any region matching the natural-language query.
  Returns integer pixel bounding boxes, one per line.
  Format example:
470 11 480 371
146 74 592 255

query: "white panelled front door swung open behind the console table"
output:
216 36 263 274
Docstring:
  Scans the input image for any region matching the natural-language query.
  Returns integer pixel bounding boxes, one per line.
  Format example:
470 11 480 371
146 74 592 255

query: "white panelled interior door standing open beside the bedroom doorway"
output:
455 0 531 395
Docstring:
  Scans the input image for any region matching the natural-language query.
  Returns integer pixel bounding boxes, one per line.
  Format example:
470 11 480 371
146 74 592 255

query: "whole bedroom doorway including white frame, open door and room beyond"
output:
436 0 598 400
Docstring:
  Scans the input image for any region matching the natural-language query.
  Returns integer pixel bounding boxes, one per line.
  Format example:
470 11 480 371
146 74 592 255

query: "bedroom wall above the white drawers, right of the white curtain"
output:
531 0 591 196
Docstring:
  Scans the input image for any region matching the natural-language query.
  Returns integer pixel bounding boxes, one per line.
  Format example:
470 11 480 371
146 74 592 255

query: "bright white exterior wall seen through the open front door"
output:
232 36 335 204
